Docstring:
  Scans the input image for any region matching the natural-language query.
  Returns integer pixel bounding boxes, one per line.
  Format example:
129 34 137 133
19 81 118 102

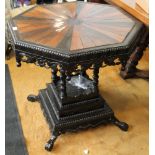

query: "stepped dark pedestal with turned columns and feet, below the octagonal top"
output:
28 64 128 151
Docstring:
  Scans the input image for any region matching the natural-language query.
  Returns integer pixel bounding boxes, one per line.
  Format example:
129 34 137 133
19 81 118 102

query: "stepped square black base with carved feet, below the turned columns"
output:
28 77 128 151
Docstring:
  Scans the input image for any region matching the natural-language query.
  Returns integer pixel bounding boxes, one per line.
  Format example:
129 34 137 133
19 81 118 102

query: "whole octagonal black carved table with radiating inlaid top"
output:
8 2 148 150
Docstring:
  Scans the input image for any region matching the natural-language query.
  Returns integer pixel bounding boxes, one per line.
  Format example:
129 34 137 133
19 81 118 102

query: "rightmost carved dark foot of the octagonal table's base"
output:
110 117 129 131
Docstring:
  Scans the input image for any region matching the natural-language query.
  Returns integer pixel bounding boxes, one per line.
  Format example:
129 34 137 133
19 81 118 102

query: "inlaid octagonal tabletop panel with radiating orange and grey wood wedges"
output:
13 2 135 51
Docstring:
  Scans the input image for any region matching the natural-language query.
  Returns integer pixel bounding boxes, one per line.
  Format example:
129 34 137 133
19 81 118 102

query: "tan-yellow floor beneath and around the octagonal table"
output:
6 51 149 155
